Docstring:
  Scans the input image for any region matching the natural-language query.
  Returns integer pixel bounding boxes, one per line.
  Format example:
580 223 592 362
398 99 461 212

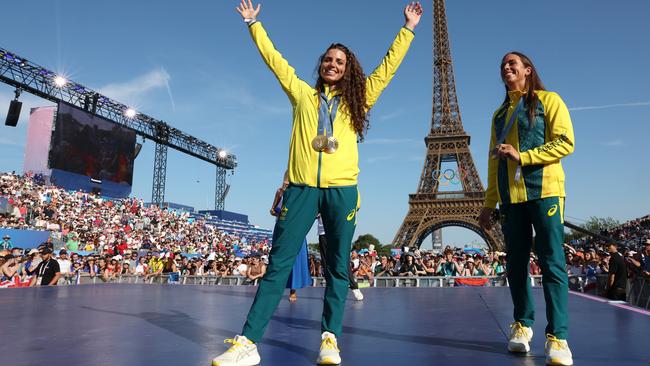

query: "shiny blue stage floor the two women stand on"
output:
0 284 650 366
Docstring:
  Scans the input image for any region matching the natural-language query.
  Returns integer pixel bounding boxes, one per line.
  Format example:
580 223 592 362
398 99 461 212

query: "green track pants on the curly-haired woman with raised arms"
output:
242 185 358 342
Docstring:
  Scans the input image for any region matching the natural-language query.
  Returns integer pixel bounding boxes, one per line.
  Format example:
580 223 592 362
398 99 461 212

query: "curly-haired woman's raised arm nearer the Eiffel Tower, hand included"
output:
366 2 422 109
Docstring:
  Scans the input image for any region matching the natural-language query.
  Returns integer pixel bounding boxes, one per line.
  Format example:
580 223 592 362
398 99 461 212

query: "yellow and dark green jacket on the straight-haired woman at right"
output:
485 90 575 208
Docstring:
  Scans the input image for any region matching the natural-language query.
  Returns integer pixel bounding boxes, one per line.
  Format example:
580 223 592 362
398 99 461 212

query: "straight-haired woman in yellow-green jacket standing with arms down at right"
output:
479 52 575 365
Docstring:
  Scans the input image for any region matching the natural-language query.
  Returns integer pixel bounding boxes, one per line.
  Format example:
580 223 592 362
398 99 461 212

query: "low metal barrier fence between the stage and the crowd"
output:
53 273 650 309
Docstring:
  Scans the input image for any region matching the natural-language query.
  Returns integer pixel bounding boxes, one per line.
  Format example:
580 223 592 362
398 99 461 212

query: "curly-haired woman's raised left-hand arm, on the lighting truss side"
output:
236 0 312 105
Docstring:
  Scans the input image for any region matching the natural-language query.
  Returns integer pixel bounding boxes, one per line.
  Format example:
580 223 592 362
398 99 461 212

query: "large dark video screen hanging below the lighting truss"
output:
50 103 136 185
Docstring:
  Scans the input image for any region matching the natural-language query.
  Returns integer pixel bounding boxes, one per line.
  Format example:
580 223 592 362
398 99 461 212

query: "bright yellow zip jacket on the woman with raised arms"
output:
249 22 414 188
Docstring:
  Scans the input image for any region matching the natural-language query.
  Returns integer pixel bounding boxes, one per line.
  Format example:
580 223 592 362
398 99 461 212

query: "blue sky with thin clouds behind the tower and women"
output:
0 0 650 245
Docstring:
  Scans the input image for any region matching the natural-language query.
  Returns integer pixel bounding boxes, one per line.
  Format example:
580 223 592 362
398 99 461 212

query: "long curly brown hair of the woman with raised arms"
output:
316 43 370 142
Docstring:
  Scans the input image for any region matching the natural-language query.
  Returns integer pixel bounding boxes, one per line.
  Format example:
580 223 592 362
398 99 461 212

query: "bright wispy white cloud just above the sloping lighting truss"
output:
98 67 174 108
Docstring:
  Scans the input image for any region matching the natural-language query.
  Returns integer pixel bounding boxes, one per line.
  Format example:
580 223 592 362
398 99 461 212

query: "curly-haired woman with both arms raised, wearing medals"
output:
212 0 422 366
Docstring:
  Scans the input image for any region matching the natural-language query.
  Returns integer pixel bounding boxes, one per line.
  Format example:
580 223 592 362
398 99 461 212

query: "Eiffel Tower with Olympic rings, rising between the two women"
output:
393 0 504 250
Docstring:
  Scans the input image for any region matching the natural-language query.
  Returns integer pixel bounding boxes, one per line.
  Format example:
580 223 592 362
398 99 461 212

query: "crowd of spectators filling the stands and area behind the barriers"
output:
0 174 650 294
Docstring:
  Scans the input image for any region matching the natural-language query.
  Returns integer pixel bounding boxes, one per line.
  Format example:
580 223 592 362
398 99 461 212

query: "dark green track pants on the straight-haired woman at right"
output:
501 197 569 339
